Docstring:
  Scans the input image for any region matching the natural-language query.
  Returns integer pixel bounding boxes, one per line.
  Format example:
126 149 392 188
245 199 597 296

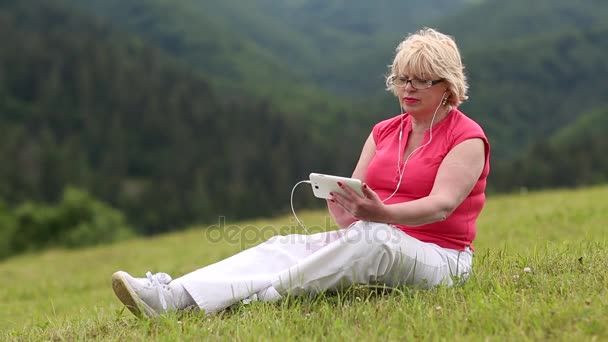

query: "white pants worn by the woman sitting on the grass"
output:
175 221 472 313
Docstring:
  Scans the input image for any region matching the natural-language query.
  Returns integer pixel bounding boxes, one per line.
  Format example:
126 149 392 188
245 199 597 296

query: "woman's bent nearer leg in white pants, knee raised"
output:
272 222 472 295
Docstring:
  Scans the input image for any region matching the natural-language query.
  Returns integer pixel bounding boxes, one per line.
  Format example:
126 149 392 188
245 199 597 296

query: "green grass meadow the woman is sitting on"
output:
0 186 608 341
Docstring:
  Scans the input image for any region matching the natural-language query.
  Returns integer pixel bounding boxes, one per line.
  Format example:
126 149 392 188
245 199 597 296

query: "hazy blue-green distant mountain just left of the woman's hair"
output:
247 0 469 93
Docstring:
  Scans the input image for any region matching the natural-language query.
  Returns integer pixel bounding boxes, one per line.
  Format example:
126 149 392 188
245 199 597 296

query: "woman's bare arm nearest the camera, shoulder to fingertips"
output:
335 138 485 226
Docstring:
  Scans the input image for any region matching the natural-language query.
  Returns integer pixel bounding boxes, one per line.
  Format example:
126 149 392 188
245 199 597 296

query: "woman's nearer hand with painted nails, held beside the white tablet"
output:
330 182 390 223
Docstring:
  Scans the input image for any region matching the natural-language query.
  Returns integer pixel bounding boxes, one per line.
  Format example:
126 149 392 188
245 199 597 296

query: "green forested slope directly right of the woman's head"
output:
462 26 608 159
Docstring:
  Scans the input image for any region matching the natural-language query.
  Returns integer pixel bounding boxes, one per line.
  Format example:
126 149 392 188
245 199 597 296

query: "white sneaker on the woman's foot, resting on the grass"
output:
112 271 189 317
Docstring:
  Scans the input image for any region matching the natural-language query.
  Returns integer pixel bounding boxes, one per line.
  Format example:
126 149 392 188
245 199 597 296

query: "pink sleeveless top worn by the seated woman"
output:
365 109 490 250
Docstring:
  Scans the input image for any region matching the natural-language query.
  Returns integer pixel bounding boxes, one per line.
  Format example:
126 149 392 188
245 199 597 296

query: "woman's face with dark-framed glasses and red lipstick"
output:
394 75 449 115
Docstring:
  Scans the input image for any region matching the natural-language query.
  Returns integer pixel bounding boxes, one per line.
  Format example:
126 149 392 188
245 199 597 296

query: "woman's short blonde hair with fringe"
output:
386 28 469 107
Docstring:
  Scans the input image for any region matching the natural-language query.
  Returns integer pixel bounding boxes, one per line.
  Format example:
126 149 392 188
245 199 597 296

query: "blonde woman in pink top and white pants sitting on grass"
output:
112 29 490 316
